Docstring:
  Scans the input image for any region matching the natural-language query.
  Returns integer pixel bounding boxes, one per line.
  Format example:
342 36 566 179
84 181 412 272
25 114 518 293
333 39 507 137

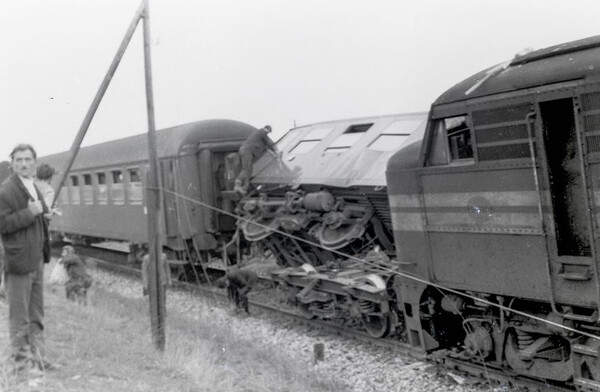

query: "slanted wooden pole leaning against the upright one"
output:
49 1 145 207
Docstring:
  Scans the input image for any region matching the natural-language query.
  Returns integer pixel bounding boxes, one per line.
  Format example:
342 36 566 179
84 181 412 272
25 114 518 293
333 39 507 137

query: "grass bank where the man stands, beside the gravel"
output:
0 278 346 392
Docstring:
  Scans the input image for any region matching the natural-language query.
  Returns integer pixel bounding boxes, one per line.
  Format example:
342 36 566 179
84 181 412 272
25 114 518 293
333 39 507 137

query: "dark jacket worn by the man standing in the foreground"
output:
0 174 50 275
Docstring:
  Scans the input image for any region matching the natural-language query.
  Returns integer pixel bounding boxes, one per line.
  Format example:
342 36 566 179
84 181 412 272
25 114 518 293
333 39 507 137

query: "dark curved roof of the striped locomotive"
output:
433 35 600 105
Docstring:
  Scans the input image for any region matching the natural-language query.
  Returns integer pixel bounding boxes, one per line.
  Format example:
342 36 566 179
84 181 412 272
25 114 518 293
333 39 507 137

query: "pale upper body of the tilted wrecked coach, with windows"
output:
252 113 427 187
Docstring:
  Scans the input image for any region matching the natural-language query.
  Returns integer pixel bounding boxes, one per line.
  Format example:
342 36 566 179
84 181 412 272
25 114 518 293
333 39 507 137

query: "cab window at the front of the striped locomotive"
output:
428 116 474 166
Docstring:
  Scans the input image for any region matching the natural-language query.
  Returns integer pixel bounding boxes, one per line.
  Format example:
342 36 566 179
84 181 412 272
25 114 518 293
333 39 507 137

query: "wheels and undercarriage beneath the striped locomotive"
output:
420 287 600 391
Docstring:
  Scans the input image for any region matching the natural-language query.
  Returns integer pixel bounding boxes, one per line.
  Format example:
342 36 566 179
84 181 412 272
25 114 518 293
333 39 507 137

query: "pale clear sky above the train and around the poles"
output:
0 0 600 160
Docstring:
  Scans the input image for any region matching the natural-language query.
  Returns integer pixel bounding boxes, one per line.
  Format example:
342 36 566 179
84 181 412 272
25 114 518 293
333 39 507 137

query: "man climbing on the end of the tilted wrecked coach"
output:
233 125 278 195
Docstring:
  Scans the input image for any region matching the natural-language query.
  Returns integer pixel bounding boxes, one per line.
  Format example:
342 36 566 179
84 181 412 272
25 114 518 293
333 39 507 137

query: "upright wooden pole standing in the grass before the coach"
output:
143 0 166 351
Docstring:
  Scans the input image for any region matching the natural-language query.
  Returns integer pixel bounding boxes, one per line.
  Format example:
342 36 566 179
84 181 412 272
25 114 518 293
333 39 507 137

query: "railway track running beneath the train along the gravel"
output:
75 248 575 392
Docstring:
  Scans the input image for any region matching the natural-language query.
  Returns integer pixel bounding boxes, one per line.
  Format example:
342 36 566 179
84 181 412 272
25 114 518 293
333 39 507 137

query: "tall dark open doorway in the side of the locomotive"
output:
537 97 599 306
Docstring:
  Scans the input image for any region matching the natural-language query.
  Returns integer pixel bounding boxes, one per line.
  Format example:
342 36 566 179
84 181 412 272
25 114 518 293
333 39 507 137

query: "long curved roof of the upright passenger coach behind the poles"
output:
39 120 255 170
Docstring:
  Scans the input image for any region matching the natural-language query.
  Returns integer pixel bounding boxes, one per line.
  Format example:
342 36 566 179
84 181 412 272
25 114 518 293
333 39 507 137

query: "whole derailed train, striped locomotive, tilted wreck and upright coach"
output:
36 36 600 390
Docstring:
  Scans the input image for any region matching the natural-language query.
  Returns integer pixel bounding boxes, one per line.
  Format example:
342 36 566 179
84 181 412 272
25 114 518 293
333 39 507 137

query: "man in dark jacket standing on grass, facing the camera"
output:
0 144 51 370
